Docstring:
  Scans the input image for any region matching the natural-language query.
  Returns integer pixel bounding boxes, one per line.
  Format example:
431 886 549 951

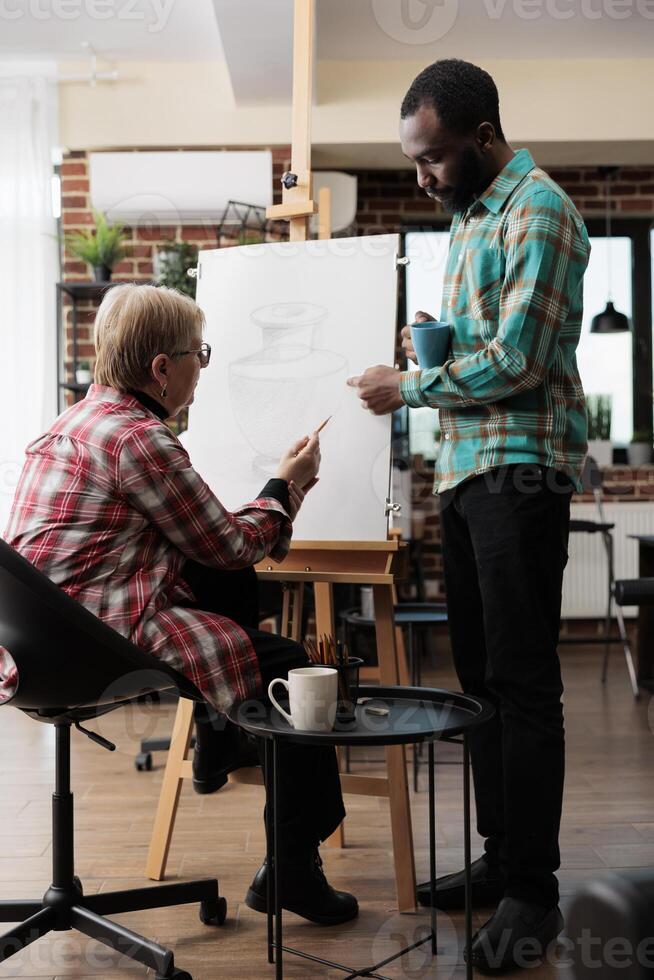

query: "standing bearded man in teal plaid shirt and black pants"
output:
348 60 590 972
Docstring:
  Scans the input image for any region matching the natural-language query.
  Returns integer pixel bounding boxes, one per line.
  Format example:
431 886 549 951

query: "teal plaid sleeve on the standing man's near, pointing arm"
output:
400 190 588 408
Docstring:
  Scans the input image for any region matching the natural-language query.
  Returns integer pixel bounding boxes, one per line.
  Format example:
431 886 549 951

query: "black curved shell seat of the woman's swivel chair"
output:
0 539 202 713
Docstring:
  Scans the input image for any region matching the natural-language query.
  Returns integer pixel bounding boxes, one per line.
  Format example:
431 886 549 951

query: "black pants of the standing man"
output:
441 464 573 905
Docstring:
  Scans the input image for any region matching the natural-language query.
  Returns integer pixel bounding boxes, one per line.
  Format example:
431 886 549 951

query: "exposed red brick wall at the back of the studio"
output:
62 146 654 597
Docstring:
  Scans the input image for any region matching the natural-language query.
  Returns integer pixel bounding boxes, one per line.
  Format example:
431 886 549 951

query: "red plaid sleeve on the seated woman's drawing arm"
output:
117 425 292 569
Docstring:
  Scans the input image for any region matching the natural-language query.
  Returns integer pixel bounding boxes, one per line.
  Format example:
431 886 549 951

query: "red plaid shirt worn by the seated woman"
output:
0 385 292 711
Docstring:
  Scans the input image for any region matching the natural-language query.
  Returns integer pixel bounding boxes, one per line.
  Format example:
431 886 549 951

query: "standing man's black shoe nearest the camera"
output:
471 898 563 974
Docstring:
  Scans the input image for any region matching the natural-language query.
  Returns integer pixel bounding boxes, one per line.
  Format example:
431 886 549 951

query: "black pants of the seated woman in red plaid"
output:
183 561 345 856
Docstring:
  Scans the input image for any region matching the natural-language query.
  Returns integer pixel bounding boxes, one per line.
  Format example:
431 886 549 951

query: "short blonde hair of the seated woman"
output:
93 283 204 391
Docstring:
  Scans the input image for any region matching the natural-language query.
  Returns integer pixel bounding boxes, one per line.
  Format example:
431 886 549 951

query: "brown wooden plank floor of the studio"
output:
0 648 654 980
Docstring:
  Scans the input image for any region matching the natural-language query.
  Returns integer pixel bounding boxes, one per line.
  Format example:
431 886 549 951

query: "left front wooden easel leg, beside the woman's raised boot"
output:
145 698 194 881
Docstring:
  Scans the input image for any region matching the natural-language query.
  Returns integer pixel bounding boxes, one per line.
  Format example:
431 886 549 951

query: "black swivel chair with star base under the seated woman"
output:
0 540 227 980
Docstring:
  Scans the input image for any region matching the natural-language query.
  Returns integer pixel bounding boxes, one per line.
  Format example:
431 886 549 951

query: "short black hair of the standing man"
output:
400 58 504 141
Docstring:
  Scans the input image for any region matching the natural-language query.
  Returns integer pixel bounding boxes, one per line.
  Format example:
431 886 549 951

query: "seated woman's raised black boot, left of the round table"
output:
193 704 259 794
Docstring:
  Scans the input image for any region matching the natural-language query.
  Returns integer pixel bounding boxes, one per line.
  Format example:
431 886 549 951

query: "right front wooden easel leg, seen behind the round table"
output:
373 585 416 912
